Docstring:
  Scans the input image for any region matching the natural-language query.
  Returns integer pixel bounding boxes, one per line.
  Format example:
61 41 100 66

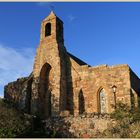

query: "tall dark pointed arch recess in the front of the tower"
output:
39 63 52 119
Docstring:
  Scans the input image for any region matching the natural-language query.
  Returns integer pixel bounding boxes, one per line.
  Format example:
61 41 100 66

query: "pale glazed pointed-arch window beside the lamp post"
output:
99 89 107 113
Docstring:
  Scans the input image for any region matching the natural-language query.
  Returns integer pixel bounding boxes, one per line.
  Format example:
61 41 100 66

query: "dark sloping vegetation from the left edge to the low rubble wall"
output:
0 99 61 138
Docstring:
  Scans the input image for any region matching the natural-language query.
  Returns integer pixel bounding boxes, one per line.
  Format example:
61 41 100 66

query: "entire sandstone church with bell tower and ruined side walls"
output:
4 12 140 118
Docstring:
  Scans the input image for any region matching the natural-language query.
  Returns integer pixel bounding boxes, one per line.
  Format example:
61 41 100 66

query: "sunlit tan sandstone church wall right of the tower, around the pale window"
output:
67 61 131 115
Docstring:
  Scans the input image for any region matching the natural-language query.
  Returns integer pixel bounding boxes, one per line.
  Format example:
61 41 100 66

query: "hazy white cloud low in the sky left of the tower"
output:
0 45 35 96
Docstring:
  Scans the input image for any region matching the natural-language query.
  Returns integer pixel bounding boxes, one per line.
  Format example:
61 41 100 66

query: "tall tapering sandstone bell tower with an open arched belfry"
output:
31 11 66 118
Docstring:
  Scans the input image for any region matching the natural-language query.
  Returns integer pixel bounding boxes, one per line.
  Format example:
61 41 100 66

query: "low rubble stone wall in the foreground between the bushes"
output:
45 113 113 138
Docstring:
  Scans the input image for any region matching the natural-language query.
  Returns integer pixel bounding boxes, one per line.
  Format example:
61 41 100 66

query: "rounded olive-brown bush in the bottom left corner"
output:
0 99 32 138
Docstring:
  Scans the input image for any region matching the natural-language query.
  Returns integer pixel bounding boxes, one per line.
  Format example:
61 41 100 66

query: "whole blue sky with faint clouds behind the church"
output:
0 2 140 96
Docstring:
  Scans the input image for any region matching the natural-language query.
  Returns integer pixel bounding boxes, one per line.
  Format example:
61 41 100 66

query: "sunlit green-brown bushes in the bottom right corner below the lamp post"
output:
102 102 140 138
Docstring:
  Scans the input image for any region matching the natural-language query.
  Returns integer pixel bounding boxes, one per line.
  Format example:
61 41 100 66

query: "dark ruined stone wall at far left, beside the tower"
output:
4 75 32 113
